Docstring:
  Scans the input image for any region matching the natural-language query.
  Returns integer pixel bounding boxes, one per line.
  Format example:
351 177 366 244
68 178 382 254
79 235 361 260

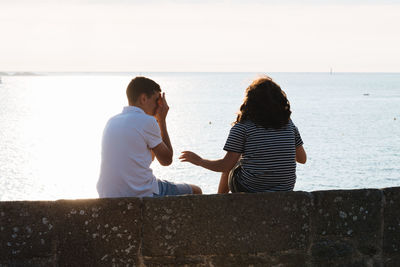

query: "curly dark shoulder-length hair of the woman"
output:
235 76 292 129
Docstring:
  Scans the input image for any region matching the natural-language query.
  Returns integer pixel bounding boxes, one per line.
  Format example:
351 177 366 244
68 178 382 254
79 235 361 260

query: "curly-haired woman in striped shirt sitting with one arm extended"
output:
179 77 307 193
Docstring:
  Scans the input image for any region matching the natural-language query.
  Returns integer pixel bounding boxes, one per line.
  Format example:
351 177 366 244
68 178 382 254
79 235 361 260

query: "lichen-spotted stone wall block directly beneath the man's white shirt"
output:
55 198 142 266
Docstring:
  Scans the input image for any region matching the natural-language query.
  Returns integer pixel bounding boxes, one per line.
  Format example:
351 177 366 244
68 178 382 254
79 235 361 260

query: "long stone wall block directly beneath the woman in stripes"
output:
143 192 311 263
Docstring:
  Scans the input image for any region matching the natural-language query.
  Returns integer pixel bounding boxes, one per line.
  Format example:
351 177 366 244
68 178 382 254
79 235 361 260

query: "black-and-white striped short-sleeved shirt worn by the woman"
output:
224 120 303 192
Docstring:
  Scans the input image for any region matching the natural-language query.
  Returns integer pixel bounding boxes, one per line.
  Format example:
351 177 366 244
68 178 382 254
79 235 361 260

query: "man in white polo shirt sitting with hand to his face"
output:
97 77 202 198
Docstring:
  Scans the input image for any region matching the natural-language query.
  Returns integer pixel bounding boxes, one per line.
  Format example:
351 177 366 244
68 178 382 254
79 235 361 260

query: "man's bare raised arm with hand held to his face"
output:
152 93 174 166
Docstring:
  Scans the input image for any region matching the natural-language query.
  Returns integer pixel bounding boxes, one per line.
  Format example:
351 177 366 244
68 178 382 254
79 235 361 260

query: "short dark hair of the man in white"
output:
126 76 161 103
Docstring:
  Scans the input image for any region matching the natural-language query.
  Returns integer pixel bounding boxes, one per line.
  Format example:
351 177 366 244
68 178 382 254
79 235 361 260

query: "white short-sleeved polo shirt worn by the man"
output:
97 106 162 198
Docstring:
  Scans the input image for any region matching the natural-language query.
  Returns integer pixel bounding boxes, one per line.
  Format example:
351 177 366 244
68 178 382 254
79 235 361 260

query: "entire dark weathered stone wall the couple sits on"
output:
0 188 400 266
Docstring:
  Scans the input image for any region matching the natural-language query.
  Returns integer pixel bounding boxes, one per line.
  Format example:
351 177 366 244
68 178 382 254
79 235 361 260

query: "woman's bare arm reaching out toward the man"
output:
179 151 241 172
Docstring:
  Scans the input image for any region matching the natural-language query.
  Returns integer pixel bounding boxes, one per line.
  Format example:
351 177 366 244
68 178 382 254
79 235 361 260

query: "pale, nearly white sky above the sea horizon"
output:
0 0 400 72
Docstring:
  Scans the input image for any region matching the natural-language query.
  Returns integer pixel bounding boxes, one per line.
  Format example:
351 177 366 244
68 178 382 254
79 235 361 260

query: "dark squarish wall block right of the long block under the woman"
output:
311 189 383 266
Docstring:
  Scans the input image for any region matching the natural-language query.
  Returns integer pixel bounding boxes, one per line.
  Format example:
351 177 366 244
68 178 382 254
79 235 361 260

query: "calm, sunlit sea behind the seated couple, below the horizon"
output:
0 73 400 201
